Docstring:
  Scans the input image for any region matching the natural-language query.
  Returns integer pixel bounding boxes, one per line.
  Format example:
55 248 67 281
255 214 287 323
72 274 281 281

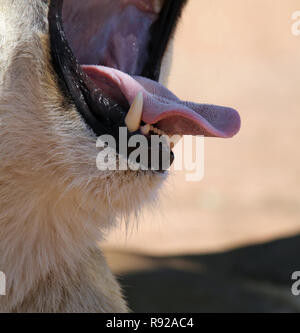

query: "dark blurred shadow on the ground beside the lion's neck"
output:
105 236 300 312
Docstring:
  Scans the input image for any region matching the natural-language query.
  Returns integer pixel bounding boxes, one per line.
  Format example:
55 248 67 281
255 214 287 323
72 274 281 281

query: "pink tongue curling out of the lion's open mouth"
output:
82 66 241 138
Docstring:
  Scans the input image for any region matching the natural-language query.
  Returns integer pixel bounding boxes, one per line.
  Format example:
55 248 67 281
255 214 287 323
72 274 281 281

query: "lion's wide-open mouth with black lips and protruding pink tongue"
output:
49 0 240 170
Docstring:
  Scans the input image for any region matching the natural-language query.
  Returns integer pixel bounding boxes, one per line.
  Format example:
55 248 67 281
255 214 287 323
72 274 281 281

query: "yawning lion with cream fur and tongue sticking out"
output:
0 0 240 313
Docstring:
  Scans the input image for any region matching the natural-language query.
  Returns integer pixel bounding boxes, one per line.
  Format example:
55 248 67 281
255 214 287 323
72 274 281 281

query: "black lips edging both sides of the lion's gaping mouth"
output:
48 0 187 170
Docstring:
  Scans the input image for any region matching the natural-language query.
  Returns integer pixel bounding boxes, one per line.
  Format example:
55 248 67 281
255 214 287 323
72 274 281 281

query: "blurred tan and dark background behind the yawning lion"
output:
106 0 300 312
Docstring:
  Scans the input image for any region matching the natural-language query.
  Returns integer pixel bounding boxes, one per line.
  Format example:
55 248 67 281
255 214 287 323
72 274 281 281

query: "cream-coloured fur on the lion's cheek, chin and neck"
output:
0 0 171 312
